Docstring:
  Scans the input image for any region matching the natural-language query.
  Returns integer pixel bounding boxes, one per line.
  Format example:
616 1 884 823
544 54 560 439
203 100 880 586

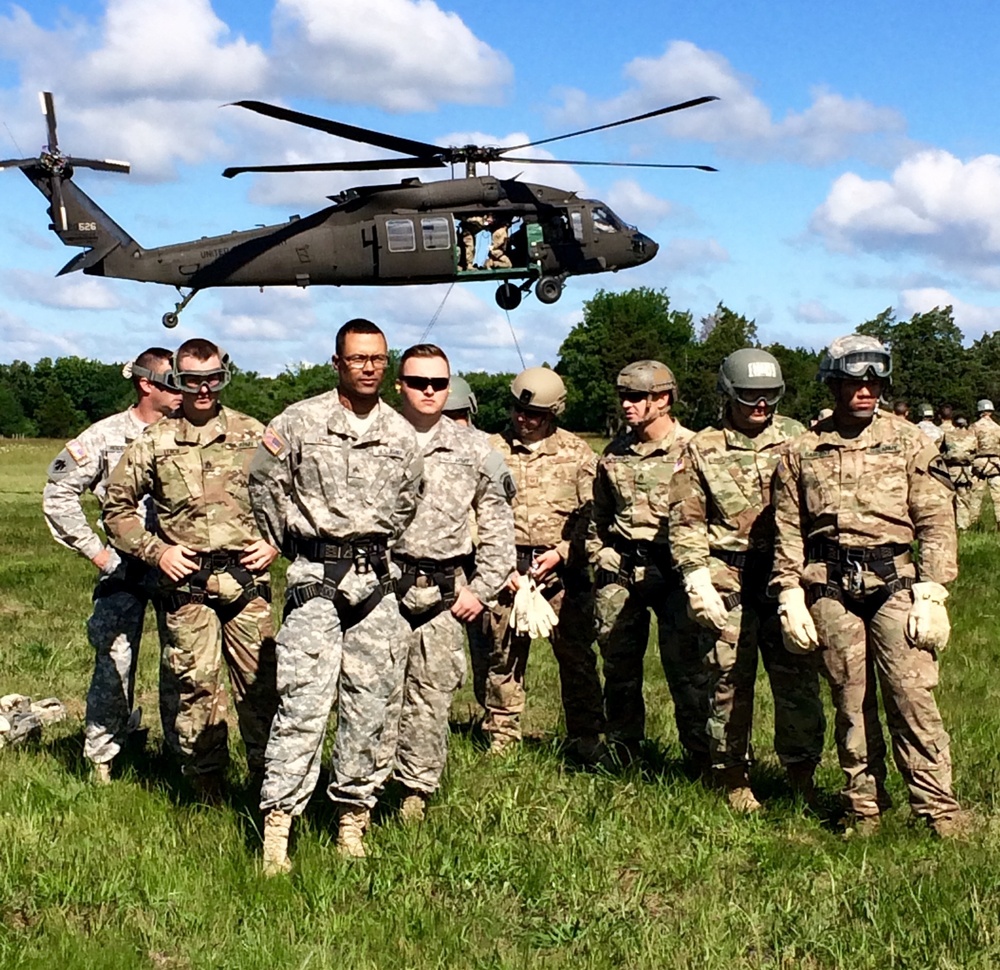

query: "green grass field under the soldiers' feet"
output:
0 441 1000 970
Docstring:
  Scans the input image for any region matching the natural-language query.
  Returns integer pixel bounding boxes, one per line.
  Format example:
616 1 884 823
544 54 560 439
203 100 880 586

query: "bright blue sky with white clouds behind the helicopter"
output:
0 0 1000 373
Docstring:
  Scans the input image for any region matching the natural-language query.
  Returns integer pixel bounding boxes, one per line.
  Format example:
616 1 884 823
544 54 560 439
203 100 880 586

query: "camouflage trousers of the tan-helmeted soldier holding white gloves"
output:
483 577 604 738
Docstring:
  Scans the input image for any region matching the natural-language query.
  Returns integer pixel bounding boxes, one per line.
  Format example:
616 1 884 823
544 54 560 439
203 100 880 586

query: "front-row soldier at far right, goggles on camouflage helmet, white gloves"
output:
772 334 966 836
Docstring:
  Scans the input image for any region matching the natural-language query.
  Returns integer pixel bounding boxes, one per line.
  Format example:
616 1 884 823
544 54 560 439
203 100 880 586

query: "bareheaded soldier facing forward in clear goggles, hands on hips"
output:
104 338 278 802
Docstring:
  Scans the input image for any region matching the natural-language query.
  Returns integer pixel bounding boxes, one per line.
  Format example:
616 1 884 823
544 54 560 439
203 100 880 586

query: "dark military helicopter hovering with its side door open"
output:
0 92 718 327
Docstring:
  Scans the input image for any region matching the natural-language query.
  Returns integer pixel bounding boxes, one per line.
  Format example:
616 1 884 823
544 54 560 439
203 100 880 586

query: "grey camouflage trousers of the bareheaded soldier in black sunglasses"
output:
395 610 465 795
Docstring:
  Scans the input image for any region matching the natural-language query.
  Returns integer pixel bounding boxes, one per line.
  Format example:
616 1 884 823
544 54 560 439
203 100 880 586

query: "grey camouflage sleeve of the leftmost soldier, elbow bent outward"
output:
42 432 104 559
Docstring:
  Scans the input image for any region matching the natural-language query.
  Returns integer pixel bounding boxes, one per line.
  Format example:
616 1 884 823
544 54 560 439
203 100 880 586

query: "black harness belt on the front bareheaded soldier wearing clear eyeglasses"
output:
284 536 395 630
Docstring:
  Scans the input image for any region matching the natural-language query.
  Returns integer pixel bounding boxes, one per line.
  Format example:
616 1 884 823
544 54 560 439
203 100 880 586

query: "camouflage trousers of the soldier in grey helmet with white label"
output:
700 604 826 768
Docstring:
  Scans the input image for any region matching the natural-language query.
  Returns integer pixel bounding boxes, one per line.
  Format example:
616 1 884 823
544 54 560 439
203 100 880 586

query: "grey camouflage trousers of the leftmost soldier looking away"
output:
83 557 156 764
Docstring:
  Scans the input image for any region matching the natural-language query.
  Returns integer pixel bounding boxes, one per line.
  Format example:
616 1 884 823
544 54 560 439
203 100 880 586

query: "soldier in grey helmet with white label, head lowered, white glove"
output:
670 348 825 812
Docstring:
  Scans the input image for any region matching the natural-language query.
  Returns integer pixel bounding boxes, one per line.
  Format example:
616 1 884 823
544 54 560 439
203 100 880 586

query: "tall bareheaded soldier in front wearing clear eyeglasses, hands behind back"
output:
250 319 421 875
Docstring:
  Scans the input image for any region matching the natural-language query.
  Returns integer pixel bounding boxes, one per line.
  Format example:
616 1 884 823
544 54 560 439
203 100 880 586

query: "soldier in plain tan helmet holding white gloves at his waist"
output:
483 367 604 761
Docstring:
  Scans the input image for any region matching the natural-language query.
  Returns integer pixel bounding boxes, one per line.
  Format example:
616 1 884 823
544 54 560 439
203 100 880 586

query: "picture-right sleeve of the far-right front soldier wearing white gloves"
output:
908 444 958 583
